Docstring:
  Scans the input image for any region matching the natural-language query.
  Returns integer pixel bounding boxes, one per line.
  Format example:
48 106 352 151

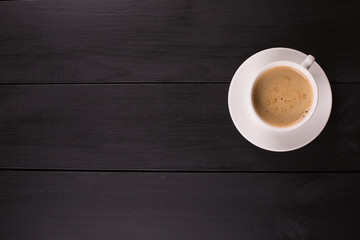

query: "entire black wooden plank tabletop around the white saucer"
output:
0 0 360 240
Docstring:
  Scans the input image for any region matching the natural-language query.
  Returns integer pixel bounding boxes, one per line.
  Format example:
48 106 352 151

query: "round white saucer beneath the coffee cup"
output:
228 48 332 152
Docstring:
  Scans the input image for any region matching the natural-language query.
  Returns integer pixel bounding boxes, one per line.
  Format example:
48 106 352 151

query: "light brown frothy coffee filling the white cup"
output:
251 66 313 127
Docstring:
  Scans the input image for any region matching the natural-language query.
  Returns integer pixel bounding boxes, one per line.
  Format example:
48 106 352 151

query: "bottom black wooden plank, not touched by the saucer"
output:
0 171 360 240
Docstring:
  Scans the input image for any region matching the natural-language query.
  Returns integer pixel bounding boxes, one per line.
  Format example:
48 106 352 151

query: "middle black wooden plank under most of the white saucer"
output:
0 84 360 171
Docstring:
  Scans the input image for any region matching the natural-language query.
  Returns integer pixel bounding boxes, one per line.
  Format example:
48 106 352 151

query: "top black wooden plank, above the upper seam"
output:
0 0 360 83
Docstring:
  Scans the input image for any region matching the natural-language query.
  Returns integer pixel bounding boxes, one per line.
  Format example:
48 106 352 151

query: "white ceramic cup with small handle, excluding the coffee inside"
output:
248 55 319 131
